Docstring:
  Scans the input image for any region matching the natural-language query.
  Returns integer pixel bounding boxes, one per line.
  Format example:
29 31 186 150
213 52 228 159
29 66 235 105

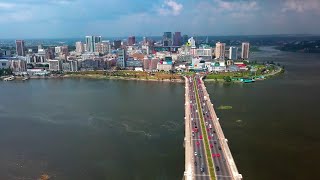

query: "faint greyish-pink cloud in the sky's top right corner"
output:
282 0 320 13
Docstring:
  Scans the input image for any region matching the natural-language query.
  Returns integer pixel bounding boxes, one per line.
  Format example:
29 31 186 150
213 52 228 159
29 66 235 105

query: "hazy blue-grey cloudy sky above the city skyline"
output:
0 0 320 39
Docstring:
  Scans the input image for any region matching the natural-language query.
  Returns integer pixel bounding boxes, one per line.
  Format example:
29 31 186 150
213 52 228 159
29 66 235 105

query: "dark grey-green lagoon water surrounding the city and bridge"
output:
0 47 320 180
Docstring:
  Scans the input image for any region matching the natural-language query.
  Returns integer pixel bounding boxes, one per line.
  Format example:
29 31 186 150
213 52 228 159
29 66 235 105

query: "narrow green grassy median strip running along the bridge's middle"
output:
194 78 216 180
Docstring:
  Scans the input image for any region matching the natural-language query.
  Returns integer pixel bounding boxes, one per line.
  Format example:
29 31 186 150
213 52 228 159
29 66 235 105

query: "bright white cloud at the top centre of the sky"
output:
158 0 183 16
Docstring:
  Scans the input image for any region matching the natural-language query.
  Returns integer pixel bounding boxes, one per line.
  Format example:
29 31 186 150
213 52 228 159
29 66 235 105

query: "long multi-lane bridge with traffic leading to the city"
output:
183 75 242 180
